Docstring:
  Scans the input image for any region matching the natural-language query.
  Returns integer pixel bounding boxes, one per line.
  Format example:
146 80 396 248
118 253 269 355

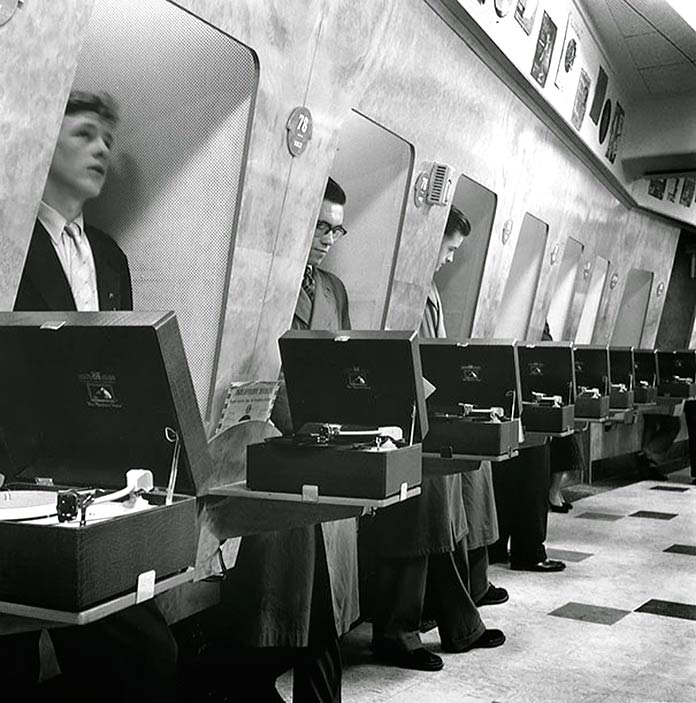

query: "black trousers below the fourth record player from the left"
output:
488 444 549 564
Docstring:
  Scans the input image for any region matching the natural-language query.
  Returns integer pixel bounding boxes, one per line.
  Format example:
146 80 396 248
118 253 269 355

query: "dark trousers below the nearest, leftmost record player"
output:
0 601 177 703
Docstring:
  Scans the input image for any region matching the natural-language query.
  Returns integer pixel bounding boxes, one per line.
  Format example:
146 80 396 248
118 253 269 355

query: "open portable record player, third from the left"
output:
420 339 520 461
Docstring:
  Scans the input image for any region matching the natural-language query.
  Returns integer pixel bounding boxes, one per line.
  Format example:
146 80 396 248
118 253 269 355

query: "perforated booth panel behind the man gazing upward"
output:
75 0 257 414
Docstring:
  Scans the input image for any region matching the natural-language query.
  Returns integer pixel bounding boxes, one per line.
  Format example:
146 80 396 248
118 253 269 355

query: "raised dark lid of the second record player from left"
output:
278 330 428 441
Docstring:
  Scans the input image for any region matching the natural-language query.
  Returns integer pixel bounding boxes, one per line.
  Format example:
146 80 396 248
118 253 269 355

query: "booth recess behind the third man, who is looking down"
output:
435 175 498 339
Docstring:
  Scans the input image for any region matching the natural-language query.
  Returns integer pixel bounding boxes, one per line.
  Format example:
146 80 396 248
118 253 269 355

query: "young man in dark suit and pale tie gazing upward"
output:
7 91 177 703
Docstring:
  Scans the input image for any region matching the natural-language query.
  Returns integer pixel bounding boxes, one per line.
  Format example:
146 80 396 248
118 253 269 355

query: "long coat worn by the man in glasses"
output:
223 269 359 647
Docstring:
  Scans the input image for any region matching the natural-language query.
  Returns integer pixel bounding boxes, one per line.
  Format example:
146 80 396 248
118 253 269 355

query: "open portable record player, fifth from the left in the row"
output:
574 344 611 422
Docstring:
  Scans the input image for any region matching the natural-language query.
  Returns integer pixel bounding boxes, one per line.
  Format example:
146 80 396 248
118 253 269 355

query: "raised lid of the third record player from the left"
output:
420 339 522 417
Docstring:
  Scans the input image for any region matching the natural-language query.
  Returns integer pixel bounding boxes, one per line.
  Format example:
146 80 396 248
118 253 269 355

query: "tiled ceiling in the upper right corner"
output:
581 0 696 99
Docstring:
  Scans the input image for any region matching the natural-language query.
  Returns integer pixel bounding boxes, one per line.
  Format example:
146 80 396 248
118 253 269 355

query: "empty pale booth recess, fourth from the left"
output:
495 213 549 339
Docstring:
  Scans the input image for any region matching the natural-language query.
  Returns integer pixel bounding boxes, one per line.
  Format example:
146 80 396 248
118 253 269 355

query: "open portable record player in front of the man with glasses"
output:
247 330 427 501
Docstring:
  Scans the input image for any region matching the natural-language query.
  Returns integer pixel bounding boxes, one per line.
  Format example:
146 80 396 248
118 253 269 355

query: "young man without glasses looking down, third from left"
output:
365 207 505 671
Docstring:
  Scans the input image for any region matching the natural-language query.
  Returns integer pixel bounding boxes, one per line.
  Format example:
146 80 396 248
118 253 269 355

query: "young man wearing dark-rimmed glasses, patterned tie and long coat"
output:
221 178 359 703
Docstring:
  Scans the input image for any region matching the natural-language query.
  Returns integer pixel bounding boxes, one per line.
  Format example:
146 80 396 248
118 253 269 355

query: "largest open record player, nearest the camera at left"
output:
0 312 210 623
